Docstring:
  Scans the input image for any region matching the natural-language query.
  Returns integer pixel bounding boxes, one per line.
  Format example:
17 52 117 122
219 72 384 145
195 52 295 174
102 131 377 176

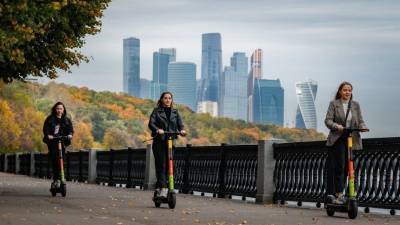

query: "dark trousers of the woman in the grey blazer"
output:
327 135 347 195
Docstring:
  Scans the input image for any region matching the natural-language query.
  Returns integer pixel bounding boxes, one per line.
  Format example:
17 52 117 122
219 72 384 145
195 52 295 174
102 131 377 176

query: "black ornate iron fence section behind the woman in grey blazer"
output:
274 138 400 209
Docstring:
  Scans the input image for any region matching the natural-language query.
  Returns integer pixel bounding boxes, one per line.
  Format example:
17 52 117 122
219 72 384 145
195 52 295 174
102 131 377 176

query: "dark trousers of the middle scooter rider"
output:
152 140 168 188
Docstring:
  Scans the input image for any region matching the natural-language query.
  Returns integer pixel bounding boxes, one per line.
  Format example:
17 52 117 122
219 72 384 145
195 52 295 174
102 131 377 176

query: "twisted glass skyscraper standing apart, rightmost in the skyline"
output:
296 80 318 129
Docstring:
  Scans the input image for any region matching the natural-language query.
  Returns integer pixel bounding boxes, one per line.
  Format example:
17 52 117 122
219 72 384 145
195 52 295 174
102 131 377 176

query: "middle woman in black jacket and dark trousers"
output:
149 92 186 197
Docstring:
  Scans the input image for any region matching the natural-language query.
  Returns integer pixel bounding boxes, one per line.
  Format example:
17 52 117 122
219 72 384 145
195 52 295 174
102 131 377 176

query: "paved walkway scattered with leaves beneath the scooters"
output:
0 173 400 225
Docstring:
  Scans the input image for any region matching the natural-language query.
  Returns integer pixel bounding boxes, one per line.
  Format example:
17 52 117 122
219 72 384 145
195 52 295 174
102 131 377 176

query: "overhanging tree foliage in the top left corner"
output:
0 0 110 83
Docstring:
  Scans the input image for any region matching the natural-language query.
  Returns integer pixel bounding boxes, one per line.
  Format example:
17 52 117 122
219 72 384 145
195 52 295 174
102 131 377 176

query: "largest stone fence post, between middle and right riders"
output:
256 139 284 204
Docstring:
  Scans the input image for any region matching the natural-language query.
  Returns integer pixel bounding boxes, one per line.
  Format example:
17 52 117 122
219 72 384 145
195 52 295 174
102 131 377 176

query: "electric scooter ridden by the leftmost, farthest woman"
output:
50 136 69 197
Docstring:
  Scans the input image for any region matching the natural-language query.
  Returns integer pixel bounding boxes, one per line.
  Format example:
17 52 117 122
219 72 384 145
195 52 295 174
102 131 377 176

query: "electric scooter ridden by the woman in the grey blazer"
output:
325 128 369 219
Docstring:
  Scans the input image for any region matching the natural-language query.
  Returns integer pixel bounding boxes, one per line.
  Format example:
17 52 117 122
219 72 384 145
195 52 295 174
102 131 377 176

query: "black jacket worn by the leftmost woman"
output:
43 115 74 146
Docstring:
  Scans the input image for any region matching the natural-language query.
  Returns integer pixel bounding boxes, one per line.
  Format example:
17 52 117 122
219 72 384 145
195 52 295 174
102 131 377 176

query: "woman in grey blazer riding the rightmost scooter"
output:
325 82 368 203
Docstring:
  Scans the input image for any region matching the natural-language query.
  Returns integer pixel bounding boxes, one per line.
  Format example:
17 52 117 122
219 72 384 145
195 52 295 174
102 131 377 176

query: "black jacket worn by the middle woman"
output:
149 107 184 140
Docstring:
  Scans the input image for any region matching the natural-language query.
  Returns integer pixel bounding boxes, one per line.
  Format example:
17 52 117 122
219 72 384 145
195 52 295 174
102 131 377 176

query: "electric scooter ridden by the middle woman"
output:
153 132 182 209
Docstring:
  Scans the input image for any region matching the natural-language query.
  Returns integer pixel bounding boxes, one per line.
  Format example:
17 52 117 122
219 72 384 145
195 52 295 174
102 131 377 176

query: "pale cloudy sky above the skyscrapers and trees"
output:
50 0 400 137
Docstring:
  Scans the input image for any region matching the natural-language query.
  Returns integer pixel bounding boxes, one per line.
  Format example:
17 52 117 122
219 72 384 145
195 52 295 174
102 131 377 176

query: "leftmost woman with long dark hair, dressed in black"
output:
43 102 74 185
